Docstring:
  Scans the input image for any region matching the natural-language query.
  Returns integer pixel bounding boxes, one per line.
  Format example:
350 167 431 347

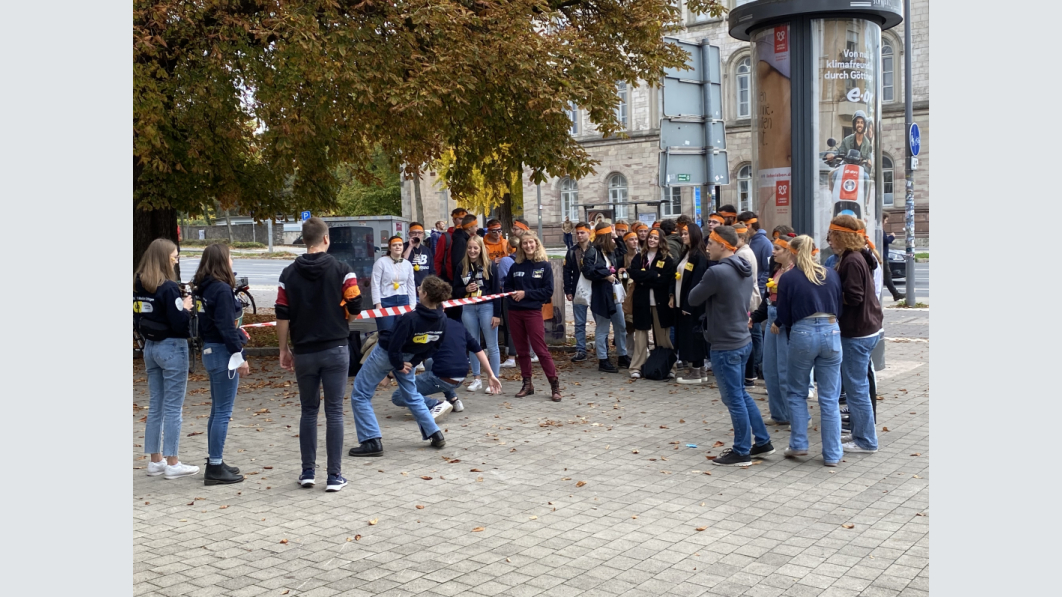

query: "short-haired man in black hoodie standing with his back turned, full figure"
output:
276 218 362 492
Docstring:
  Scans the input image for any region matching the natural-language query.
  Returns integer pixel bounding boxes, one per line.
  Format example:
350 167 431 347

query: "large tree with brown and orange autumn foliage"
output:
133 0 722 266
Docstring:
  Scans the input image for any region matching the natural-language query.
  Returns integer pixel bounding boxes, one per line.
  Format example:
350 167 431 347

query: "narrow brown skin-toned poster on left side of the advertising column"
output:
752 24 792 231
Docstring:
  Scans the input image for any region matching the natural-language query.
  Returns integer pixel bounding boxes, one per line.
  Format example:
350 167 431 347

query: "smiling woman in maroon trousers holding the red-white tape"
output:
502 231 562 403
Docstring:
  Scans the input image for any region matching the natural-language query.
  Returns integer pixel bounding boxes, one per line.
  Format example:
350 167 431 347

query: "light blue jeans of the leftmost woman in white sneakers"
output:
143 338 188 457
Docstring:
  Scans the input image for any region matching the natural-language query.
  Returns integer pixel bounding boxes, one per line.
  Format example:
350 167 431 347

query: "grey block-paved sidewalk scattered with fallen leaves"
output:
131 338 929 597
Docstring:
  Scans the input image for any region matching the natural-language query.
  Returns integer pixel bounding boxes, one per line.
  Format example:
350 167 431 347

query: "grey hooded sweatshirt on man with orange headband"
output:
689 255 756 351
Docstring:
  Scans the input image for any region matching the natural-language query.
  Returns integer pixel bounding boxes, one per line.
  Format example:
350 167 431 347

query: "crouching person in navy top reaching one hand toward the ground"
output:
399 305 501 419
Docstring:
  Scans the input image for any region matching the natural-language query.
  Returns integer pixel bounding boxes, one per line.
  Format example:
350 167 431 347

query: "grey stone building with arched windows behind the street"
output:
402 0 932 248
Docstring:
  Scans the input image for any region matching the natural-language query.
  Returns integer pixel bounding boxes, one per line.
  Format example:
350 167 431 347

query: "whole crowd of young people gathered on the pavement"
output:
134 206 887 491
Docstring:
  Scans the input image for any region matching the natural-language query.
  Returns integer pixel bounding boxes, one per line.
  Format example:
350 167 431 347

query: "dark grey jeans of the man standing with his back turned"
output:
295 346 348 475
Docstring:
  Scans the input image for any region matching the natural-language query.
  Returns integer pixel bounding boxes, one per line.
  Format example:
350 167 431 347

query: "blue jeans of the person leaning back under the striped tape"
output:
350 344 439 444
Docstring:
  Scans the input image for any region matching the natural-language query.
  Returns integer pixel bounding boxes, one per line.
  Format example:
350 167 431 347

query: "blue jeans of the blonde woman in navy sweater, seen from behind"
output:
783 318 841 463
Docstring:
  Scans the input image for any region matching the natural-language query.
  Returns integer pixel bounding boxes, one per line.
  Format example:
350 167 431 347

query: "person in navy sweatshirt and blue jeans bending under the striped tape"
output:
348 276 451 457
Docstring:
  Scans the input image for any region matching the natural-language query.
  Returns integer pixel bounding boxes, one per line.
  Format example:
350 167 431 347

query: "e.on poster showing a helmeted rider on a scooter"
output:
811 19 884 252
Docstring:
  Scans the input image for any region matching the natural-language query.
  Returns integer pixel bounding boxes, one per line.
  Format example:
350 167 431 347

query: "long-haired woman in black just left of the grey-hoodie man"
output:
672 223 708 383
